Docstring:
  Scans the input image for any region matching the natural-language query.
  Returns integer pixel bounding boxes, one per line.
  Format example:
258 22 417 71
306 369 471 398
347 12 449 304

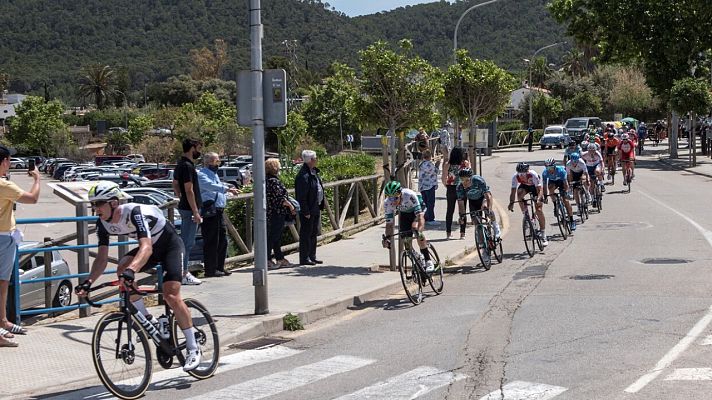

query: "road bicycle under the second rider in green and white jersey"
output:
382 231 444 305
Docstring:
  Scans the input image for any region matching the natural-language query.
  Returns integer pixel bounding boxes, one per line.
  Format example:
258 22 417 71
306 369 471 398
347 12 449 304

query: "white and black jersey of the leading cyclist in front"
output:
96 203 166 246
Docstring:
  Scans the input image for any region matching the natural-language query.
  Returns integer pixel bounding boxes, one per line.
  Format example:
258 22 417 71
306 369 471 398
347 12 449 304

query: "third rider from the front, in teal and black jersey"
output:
457 168 500 239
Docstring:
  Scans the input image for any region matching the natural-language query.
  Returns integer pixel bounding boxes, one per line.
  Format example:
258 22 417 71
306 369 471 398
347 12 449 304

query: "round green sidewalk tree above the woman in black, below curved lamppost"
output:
443 50 516 166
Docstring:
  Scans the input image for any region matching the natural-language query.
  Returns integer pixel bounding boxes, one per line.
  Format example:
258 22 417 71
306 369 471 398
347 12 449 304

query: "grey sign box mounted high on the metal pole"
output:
237 69 287 128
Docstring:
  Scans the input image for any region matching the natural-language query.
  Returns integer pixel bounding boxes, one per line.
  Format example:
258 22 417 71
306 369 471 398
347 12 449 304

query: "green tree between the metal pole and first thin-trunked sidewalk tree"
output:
302 63 359 148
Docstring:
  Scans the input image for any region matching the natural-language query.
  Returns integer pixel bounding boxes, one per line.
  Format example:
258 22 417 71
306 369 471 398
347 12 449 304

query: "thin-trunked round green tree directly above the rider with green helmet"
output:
357 40 443 181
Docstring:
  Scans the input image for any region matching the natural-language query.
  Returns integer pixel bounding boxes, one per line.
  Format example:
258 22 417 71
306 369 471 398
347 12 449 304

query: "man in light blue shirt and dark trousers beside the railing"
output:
198 153 238 278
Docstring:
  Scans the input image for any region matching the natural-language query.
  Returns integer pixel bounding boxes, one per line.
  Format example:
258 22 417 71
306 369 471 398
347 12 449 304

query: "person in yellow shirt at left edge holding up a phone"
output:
0 145 40 347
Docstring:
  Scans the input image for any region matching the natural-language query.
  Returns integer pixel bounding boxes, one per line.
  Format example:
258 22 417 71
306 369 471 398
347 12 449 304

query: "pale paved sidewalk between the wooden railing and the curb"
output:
0 157 502 398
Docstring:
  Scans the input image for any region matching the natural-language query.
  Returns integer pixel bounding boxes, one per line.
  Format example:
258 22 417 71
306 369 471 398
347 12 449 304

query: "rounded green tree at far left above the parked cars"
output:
8 96 72 155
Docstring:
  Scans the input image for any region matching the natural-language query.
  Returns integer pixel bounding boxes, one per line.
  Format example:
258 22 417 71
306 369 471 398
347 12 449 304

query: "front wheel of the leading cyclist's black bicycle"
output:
91 312 153 400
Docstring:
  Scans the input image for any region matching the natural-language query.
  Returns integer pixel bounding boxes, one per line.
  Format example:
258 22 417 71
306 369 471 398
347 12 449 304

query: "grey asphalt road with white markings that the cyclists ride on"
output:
33 151 712 400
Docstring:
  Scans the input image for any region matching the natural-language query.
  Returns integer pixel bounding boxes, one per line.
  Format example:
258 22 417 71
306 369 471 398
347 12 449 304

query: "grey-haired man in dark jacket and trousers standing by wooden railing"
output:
294 150 324 265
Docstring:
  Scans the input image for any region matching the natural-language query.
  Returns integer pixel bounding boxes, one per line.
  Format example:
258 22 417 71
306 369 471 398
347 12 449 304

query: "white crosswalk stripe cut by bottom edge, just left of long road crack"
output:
335 367 467 400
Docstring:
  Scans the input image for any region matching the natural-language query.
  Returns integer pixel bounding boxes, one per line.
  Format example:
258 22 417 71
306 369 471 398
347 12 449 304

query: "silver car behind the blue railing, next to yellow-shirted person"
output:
19 242 72 309
